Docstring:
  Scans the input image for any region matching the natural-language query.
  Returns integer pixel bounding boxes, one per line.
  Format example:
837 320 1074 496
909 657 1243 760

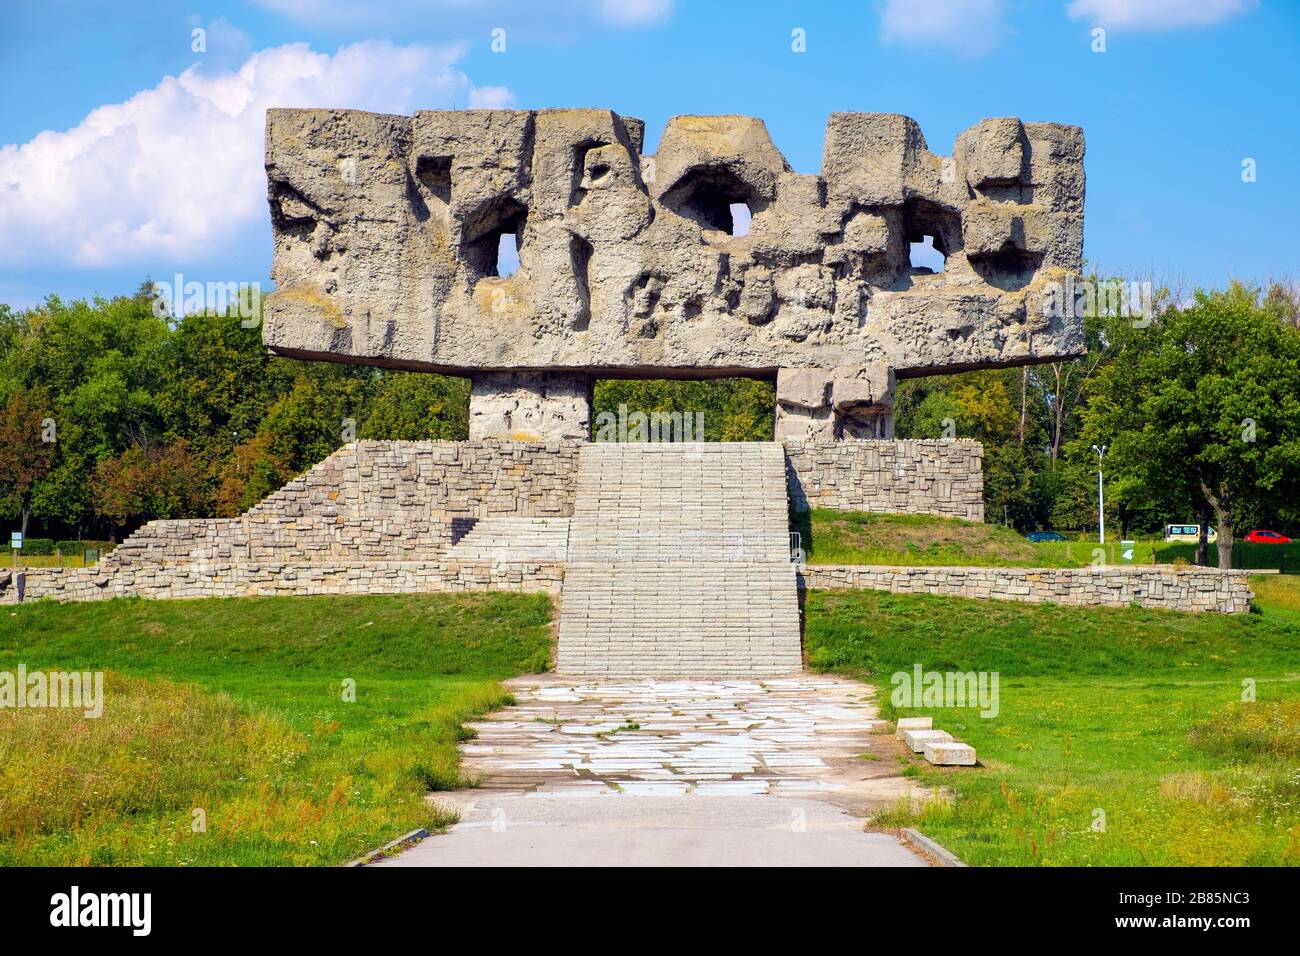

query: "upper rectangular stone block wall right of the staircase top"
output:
784 440 984 522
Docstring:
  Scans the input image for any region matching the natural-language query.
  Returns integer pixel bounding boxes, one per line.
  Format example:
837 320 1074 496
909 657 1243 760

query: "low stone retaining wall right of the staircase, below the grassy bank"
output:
800 564 1253 614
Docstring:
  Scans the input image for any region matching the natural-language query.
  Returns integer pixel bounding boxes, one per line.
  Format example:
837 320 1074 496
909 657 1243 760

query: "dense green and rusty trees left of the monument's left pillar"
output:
0 284 469 540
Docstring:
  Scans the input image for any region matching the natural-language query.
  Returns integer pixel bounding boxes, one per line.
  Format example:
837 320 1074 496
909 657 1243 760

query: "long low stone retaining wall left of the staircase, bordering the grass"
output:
0 561 564 605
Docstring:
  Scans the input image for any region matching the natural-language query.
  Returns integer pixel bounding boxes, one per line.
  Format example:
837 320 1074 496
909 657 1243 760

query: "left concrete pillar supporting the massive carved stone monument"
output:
469 372 594 441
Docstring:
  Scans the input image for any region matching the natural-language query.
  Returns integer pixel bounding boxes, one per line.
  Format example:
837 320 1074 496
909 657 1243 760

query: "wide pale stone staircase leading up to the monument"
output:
558 442 802 676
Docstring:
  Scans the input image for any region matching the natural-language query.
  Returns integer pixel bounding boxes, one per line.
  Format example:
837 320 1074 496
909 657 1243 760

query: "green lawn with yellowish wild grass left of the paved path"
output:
0 593 551 865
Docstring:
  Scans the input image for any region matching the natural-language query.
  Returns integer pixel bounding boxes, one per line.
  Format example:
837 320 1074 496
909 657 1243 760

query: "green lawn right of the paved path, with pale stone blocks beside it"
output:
807 578 1300 865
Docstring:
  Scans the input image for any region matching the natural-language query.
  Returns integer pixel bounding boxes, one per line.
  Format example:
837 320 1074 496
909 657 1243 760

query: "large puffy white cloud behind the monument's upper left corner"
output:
0 40 511 267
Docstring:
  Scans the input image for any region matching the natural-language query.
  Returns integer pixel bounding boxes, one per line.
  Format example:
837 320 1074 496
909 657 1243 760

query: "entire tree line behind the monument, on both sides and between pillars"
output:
0 282 1300 566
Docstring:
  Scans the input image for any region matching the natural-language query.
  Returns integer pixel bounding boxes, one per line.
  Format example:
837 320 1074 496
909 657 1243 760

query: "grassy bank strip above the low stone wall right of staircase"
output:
790 509 1300 574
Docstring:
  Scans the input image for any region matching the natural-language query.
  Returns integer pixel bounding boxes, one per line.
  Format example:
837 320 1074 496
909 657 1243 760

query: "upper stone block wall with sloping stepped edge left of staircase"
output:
104 441 580 567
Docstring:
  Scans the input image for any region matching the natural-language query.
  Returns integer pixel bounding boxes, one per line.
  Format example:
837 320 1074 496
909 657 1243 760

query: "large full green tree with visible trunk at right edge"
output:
1078 282 1300 568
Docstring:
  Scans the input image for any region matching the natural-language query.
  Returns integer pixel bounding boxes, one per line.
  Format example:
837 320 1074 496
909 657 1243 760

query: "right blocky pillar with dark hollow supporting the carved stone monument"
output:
776 365 894 441
